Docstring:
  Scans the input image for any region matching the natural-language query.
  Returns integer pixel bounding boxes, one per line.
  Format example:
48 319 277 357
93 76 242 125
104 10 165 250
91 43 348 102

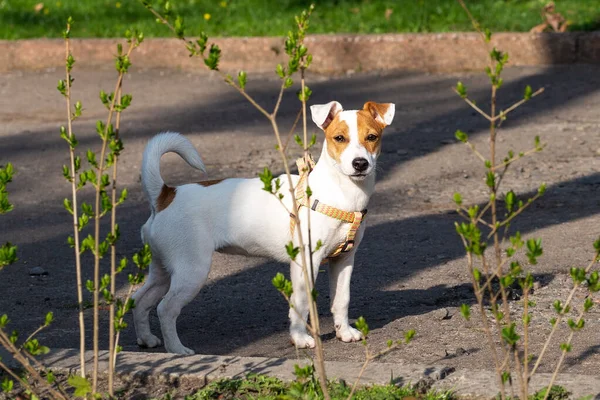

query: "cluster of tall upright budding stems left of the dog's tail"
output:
57 18 151 397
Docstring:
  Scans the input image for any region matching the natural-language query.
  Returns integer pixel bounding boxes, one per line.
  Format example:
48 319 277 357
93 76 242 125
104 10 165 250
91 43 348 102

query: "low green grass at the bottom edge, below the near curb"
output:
180 374 455 400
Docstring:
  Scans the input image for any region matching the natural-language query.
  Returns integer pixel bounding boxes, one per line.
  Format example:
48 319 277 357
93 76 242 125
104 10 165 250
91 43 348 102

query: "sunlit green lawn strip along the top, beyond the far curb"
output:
0 0 600 39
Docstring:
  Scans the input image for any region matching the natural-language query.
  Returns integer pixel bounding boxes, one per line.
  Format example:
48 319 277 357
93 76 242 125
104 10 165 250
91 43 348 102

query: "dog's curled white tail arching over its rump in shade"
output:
142 132 206 212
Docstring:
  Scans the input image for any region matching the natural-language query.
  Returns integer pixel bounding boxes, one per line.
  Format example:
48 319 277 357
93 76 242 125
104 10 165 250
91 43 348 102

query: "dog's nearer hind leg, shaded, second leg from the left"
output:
157 249 212 354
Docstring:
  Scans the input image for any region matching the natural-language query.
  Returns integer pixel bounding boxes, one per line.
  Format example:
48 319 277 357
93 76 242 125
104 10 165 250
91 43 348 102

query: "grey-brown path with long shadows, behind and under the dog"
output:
0 66 600 374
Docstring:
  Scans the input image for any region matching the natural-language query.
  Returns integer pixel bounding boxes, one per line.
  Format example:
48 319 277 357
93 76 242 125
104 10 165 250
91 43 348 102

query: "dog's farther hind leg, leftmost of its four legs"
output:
132 258 169 347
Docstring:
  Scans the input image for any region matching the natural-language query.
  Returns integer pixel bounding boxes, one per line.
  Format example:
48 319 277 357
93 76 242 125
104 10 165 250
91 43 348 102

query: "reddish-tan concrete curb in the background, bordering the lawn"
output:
0 32 600 74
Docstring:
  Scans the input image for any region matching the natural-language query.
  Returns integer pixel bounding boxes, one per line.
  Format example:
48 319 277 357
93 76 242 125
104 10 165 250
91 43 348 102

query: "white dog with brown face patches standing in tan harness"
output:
133 101 395 354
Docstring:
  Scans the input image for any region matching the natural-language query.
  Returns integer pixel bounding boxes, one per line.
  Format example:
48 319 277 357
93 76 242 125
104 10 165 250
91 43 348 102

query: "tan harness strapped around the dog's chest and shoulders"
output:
290 154 367 259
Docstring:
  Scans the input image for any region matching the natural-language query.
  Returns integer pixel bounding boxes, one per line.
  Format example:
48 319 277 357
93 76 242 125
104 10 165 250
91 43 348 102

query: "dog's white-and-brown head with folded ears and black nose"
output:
310 101 395 180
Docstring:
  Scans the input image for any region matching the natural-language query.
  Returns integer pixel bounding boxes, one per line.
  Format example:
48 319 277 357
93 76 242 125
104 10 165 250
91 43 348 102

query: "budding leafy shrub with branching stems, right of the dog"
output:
453 0 600 400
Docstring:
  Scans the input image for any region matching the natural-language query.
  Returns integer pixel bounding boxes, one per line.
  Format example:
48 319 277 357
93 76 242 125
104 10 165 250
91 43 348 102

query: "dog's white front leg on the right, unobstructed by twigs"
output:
329 252 363 342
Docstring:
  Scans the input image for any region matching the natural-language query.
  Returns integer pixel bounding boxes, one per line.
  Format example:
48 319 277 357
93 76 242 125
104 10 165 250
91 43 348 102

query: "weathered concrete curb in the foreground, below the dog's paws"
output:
37 349 600 398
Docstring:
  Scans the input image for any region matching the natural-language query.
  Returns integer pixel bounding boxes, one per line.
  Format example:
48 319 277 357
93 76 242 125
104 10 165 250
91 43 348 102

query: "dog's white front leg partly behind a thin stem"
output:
289 247 323 349
